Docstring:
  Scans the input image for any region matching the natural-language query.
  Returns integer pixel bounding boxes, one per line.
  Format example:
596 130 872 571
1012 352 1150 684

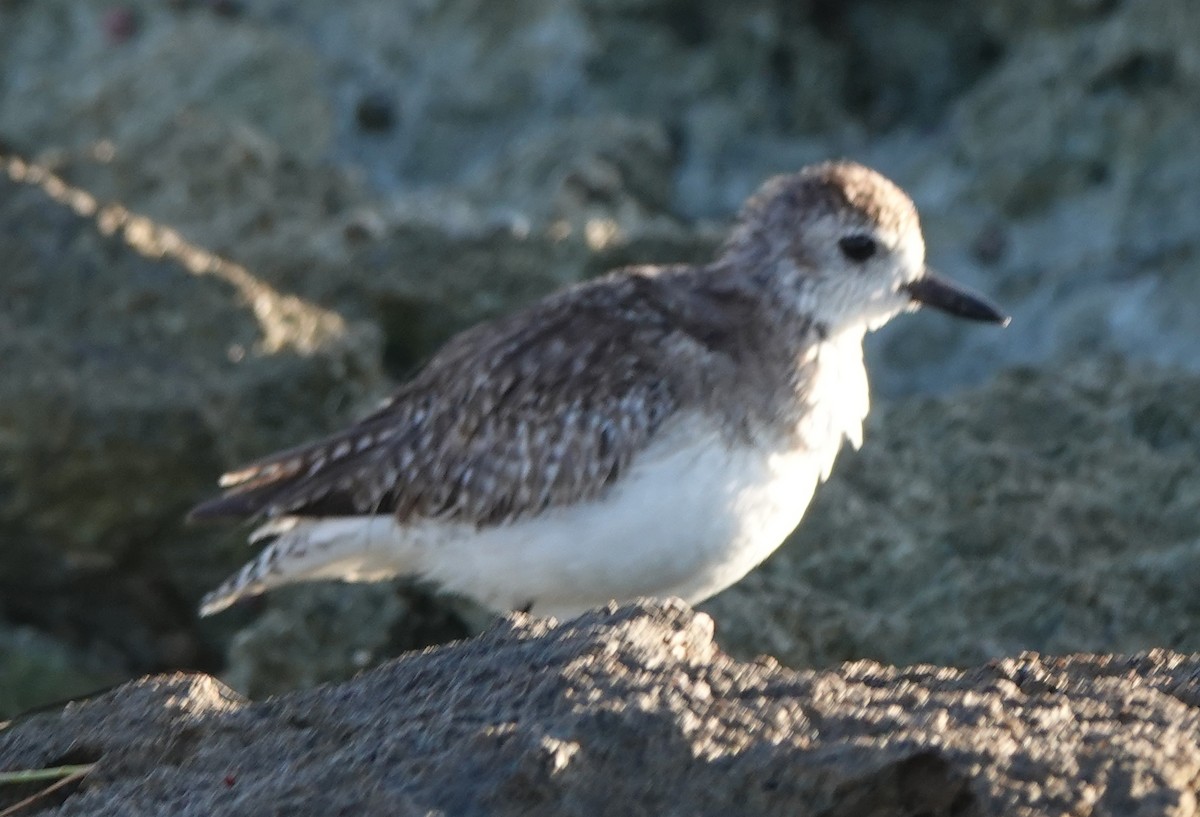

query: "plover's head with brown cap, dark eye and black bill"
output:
722 162 1008 334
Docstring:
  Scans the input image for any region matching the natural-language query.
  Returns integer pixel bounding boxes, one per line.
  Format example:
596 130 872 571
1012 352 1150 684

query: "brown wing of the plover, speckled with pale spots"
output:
191 263 748 525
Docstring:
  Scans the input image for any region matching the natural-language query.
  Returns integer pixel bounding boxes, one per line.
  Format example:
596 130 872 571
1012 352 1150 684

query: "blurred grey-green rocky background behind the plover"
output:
0 0 1200 716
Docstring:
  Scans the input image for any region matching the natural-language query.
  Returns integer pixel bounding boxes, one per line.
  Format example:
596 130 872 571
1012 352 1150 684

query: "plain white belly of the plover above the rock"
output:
397 417 841 617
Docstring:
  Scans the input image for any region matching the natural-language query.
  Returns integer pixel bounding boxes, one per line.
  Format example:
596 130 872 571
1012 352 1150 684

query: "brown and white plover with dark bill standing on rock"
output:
191 162 1008 617
